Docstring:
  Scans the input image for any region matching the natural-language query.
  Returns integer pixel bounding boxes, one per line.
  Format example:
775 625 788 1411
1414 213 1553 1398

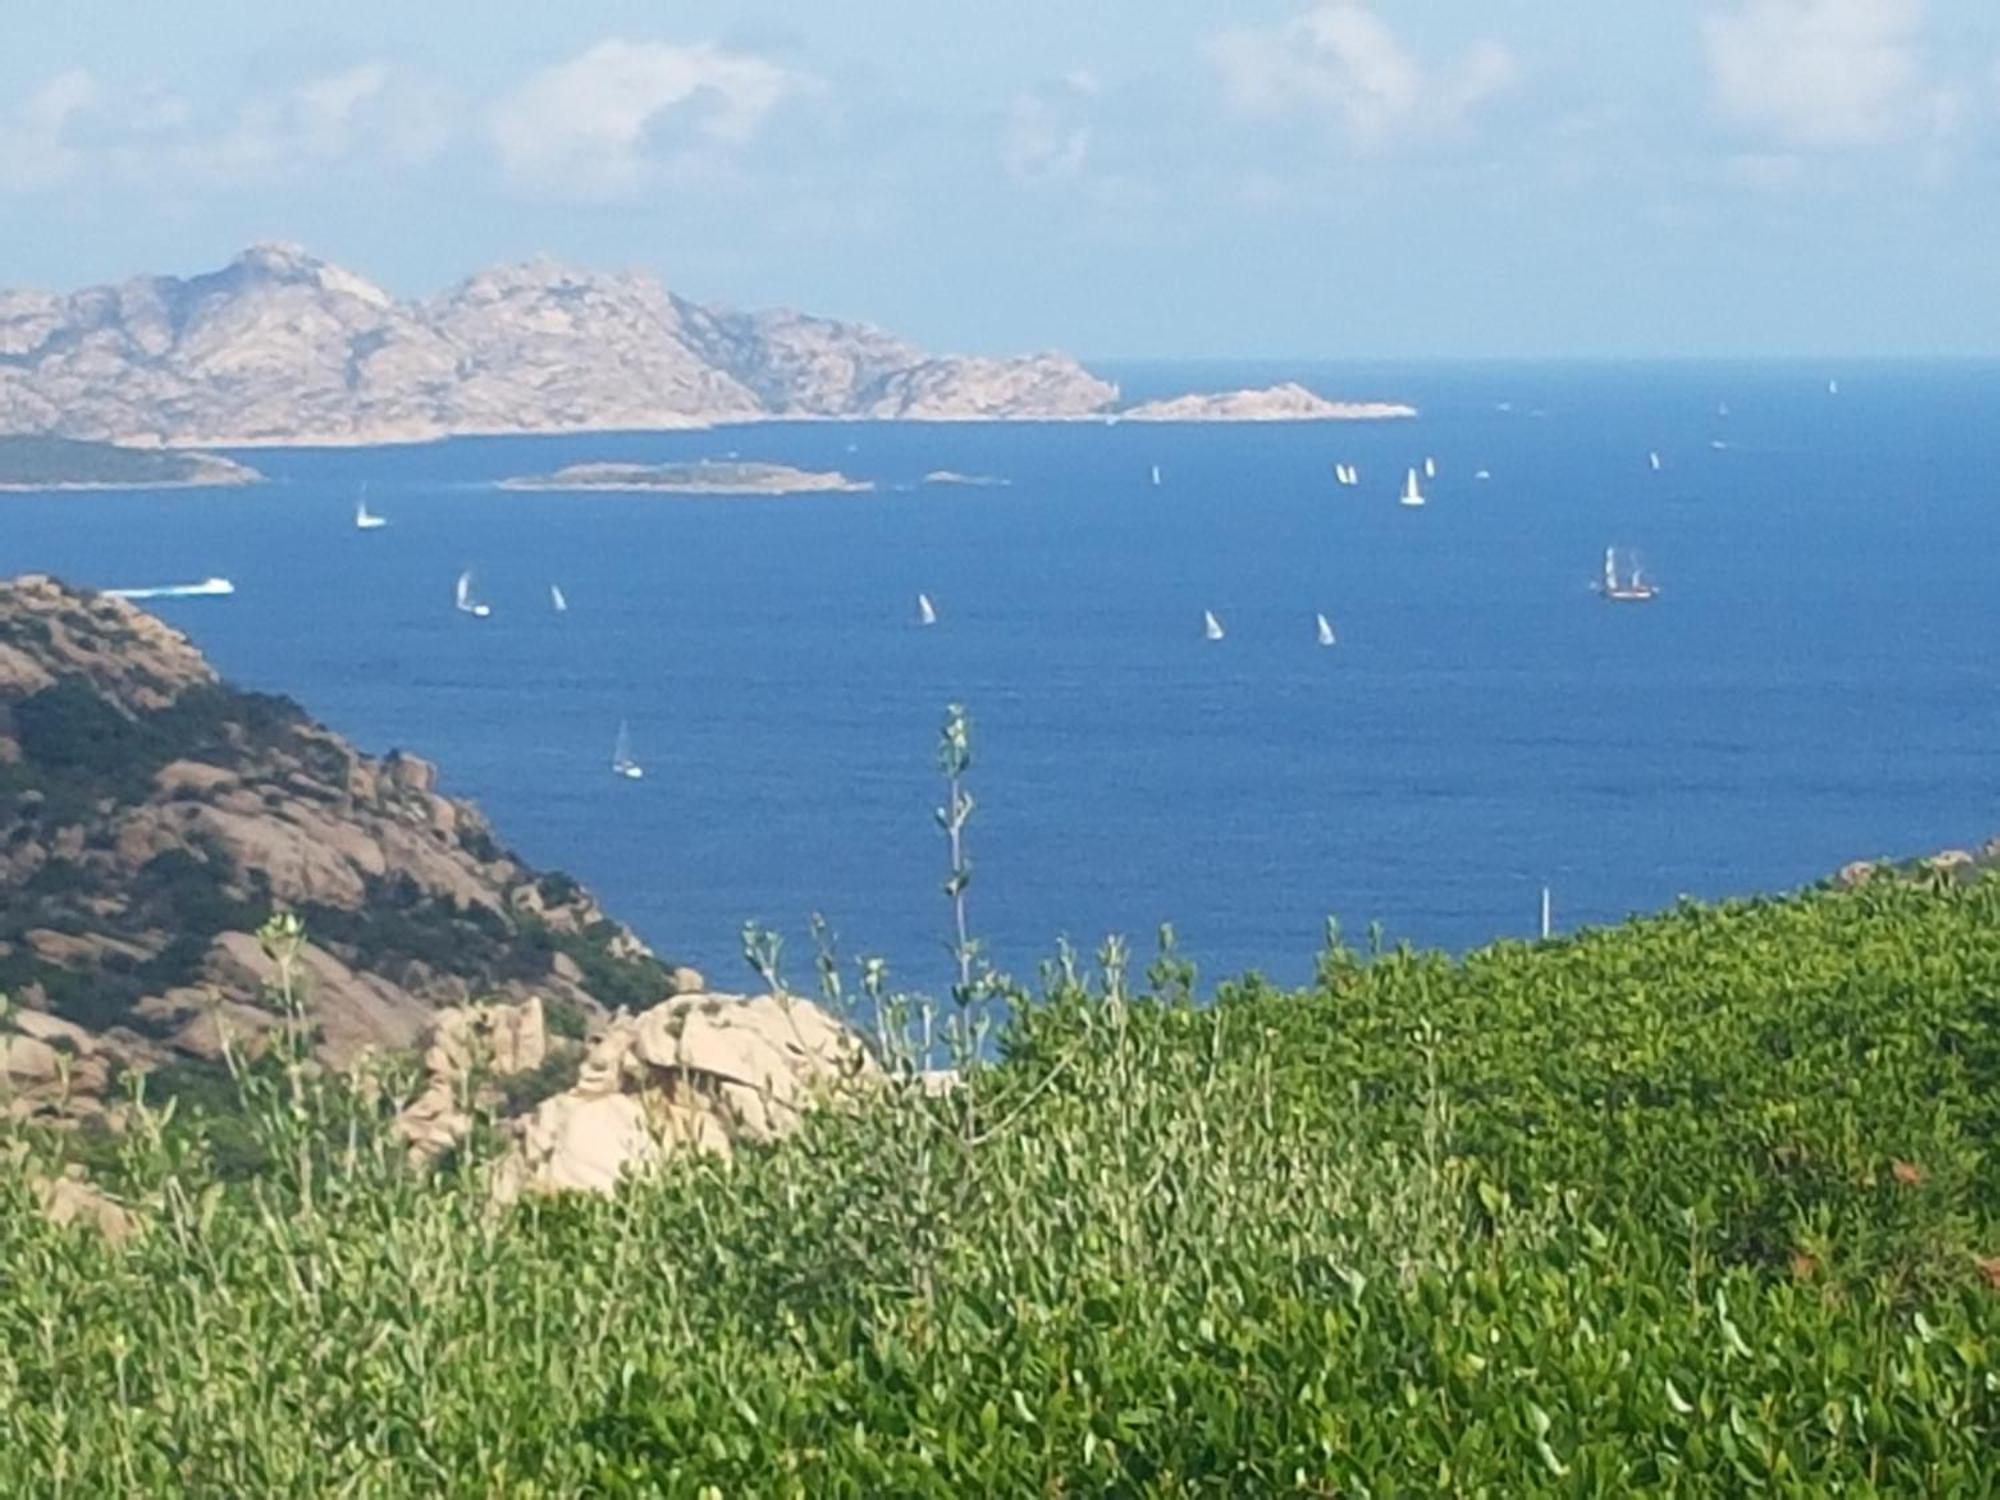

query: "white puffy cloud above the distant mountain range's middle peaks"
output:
488 40 812 198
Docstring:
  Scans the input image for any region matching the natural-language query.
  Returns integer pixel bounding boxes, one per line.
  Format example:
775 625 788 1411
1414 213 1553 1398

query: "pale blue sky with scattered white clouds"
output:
0 0 2000 358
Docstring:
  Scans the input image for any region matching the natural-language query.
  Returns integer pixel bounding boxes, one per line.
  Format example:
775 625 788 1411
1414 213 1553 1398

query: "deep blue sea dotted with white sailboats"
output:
0 362 2000 1000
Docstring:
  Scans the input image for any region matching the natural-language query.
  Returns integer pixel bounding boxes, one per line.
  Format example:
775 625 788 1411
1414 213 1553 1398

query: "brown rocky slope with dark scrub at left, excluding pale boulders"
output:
0 576 676 1116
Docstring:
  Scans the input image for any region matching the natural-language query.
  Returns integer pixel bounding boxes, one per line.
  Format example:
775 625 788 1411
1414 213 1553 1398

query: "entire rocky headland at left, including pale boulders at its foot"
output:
0 576 880 1208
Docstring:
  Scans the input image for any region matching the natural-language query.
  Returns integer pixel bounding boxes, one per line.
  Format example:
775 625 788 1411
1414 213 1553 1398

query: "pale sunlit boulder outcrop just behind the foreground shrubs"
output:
496 994 880 1200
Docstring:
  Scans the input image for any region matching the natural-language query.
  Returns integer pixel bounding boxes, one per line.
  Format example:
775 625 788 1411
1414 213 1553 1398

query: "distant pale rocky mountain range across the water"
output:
0 244 1118 446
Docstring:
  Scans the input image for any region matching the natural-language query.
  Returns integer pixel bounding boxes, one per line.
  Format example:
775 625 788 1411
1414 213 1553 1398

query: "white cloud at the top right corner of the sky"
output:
1702 0 1932 150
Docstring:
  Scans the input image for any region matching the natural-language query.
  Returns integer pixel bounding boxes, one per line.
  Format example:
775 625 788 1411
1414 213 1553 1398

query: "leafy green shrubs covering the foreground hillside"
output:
0 876 2000 1496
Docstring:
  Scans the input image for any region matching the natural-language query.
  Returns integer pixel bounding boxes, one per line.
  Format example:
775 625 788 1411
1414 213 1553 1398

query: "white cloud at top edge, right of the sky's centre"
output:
1210 0 1518 150
